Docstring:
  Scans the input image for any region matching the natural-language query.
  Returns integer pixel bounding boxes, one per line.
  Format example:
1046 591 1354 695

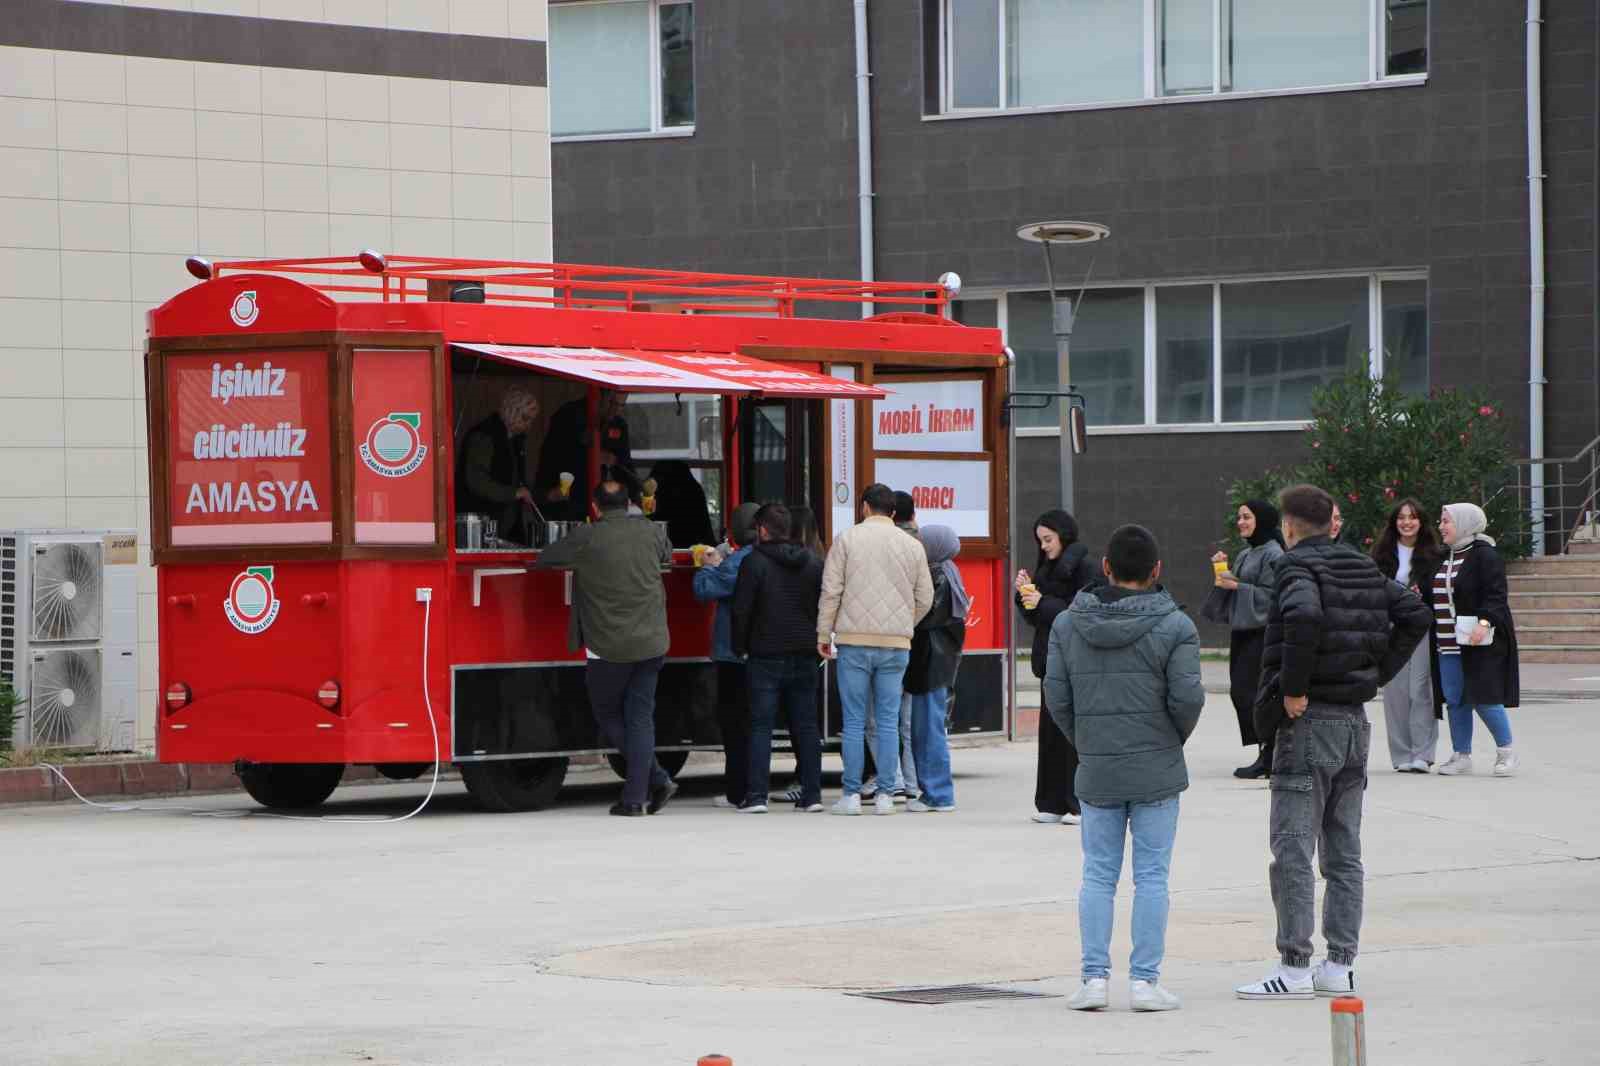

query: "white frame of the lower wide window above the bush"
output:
944 267 1432 437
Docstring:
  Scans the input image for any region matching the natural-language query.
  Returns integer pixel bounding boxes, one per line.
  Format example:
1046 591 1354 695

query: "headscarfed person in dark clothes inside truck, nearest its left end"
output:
456 386 539 544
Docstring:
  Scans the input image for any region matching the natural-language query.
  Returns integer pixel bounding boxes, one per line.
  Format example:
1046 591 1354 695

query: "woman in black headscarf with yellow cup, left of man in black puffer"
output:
1200 499 1283 779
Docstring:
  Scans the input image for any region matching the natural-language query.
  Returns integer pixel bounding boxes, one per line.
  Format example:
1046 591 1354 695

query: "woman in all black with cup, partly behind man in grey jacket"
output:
1014 511 1101 826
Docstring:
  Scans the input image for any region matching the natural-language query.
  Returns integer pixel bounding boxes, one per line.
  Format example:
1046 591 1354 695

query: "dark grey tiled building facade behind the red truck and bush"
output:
550 0 1600 643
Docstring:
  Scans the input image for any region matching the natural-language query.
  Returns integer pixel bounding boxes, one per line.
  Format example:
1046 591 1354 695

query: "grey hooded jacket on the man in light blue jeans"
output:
1045 586 1205 807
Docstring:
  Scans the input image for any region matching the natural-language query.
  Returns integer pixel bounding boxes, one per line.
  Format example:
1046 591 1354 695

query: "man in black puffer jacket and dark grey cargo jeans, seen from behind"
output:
1235 485 1429 999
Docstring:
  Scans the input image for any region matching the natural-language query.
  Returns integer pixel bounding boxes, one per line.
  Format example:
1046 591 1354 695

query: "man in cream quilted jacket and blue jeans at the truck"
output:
816 483 933 815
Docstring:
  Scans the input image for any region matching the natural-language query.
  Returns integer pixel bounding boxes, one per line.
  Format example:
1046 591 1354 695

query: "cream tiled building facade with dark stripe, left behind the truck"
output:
0 0 550 746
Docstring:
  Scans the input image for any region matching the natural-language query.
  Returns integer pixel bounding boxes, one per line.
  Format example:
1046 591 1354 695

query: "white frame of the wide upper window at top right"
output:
934 0 1434 122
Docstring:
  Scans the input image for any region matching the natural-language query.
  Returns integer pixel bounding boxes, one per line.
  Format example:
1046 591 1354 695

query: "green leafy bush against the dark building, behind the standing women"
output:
1226 373 1526 555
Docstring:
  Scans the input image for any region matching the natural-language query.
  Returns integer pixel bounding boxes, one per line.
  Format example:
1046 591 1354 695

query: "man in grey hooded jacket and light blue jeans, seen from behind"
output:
1045 525 1205 1010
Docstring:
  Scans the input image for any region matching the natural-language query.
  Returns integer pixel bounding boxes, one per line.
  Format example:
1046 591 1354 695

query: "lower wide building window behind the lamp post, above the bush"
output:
950 274 1429 432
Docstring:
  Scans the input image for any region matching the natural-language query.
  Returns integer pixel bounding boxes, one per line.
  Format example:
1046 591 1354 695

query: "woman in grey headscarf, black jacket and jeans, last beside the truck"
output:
902 525 971 813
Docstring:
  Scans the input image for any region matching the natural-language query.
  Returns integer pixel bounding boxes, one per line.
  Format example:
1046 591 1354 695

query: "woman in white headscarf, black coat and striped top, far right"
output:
1432 503 1522 778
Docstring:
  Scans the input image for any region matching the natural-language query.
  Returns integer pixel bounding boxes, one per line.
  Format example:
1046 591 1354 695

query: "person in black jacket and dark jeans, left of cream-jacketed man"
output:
733 504 822 815
